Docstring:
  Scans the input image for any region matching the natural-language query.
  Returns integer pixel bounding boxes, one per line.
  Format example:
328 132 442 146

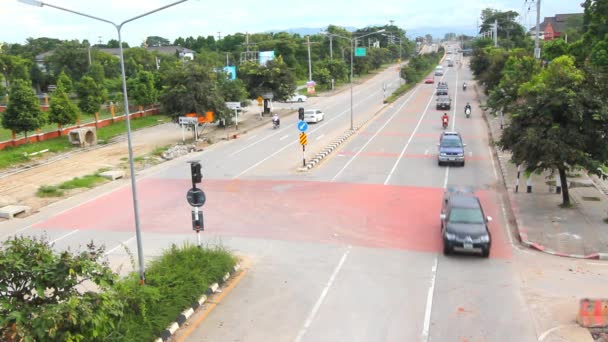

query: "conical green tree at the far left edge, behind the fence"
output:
2 80 46 141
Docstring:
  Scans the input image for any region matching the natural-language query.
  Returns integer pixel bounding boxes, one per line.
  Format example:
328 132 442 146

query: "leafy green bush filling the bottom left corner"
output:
0 237 123 342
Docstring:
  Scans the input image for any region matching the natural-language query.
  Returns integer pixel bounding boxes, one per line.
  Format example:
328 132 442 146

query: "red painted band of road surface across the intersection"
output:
34 179 511 258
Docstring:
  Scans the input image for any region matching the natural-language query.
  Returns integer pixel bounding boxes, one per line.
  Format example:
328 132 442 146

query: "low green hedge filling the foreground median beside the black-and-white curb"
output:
115 244 236 341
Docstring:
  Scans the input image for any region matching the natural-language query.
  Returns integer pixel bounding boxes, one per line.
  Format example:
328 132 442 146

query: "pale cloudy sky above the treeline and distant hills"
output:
0 0 583 46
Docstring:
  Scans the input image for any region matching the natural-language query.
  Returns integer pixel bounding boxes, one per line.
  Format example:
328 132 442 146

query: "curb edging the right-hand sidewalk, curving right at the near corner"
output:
473 84 608 260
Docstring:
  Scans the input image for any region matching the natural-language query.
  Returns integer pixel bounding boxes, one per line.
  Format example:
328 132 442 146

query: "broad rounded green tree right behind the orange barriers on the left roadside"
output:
160 62 231 121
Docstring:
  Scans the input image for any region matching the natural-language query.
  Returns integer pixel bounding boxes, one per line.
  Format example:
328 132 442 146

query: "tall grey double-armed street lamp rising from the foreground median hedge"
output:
19 0 188 285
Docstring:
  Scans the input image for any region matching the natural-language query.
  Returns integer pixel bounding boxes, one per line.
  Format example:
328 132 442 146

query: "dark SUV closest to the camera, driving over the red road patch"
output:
440 189 492 258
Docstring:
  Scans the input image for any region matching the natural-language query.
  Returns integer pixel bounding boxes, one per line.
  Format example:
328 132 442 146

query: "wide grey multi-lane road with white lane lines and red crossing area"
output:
3 44 606 341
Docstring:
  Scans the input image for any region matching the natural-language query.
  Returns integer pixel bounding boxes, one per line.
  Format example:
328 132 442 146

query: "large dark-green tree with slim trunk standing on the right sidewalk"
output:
499 56 608 206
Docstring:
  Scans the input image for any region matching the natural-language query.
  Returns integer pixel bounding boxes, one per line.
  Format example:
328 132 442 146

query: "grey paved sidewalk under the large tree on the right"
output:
474 84 608 259
